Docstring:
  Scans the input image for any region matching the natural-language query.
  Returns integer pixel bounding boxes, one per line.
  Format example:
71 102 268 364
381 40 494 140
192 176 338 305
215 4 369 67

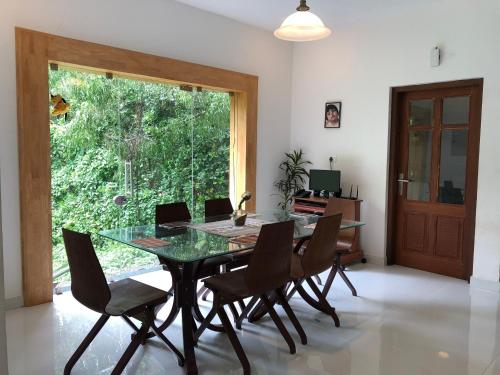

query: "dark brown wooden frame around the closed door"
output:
386 78 484 280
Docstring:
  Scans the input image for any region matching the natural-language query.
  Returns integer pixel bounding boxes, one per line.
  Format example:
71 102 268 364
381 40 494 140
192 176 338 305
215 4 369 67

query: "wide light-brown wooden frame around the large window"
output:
15 28 258 306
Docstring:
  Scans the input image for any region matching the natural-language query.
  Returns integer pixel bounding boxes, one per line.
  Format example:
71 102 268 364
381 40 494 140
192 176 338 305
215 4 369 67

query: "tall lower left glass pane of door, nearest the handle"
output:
406 130 432 201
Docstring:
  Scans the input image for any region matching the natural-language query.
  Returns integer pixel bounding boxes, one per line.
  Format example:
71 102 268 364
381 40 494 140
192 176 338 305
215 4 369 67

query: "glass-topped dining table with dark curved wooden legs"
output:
99 211 364 374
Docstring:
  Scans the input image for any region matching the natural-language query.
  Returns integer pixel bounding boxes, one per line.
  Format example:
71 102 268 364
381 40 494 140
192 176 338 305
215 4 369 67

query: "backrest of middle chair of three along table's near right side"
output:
301 214 342 277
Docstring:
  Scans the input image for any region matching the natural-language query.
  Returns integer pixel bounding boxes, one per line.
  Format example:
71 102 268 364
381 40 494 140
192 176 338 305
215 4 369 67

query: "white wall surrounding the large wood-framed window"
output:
0 0 292 298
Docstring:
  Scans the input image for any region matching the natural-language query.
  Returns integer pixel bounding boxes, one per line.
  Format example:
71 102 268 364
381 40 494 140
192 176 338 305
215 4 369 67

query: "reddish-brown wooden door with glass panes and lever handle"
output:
391 81 482 279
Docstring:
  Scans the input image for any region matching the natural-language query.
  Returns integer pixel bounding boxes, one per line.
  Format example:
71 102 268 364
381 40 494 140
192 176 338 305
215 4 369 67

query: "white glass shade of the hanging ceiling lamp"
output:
274 11 332 42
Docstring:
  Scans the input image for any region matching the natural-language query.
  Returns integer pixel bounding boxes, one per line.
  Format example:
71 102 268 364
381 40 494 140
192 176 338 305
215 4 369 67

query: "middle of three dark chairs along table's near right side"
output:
287 214 342 327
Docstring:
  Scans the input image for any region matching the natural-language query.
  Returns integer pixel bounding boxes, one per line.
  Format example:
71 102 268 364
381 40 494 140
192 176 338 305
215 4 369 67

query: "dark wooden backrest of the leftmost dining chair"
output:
62 228 111 314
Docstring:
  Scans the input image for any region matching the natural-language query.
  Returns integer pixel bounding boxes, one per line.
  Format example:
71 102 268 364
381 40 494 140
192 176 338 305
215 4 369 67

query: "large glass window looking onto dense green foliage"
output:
49 68 230 281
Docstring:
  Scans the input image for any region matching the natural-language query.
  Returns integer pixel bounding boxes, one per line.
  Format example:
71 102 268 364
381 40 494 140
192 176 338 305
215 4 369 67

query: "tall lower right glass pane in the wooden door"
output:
439 129 468 204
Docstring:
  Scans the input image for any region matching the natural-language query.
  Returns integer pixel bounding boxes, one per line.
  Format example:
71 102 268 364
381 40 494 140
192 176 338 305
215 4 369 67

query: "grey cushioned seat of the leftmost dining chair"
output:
106 279 168 316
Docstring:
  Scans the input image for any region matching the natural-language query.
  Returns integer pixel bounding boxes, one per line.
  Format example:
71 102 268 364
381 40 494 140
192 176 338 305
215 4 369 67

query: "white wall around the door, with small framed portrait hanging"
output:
291 0 500 281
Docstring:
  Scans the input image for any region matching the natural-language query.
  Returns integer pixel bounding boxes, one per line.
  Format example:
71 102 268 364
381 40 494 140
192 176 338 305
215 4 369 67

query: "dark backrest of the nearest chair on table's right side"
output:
245 221 294 294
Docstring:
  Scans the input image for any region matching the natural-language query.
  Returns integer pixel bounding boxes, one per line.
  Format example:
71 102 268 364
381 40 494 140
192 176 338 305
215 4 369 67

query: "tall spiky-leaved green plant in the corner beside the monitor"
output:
274 150 312 210
